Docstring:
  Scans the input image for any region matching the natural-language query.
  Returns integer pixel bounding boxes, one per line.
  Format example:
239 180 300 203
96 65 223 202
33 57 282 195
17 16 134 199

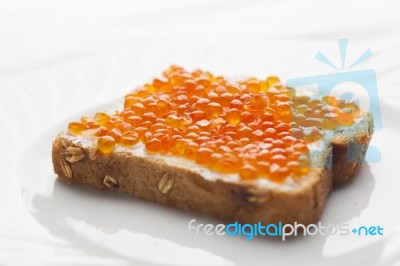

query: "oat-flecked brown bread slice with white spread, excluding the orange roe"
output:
52 110 373 225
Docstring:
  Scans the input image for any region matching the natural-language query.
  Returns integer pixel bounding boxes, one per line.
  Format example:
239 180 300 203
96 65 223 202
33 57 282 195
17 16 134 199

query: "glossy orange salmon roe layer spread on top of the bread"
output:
68 65 360 182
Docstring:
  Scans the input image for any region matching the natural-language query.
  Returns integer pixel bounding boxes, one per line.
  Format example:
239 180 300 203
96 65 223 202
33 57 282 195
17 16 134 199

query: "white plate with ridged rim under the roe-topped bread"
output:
0 44 400 265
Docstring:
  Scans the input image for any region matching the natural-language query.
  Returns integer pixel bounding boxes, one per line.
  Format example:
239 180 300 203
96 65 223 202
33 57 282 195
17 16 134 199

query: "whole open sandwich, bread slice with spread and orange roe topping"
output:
52 66 373 224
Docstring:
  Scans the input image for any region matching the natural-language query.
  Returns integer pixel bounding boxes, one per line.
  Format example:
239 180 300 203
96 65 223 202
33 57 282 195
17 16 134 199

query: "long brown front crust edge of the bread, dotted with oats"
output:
52 135 332 224
